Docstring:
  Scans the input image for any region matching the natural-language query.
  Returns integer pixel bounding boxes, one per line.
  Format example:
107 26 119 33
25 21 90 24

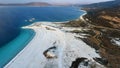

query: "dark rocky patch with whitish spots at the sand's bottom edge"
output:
70 57 106 68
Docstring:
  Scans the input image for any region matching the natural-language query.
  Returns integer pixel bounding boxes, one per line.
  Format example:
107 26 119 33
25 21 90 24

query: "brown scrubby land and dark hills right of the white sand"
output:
64 0 120 68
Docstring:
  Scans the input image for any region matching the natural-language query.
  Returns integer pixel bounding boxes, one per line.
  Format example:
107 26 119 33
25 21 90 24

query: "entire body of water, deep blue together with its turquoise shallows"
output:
0 7 84 68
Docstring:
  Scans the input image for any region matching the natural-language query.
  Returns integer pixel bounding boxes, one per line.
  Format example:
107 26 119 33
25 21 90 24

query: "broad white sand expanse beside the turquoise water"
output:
5 23 100 68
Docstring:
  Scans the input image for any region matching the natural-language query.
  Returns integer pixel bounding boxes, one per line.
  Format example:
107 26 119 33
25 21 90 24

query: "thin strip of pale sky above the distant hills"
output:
0 0 110 3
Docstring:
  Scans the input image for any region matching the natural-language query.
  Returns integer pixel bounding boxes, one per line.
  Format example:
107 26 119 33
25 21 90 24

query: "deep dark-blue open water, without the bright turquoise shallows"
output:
0 6 83 46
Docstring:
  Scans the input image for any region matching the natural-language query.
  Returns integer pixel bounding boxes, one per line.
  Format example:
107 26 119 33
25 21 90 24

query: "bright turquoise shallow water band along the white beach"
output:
0 29 35 68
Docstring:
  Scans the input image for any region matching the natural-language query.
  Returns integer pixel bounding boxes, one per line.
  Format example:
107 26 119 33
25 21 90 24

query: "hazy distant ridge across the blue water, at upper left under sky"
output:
0 2 51 6
